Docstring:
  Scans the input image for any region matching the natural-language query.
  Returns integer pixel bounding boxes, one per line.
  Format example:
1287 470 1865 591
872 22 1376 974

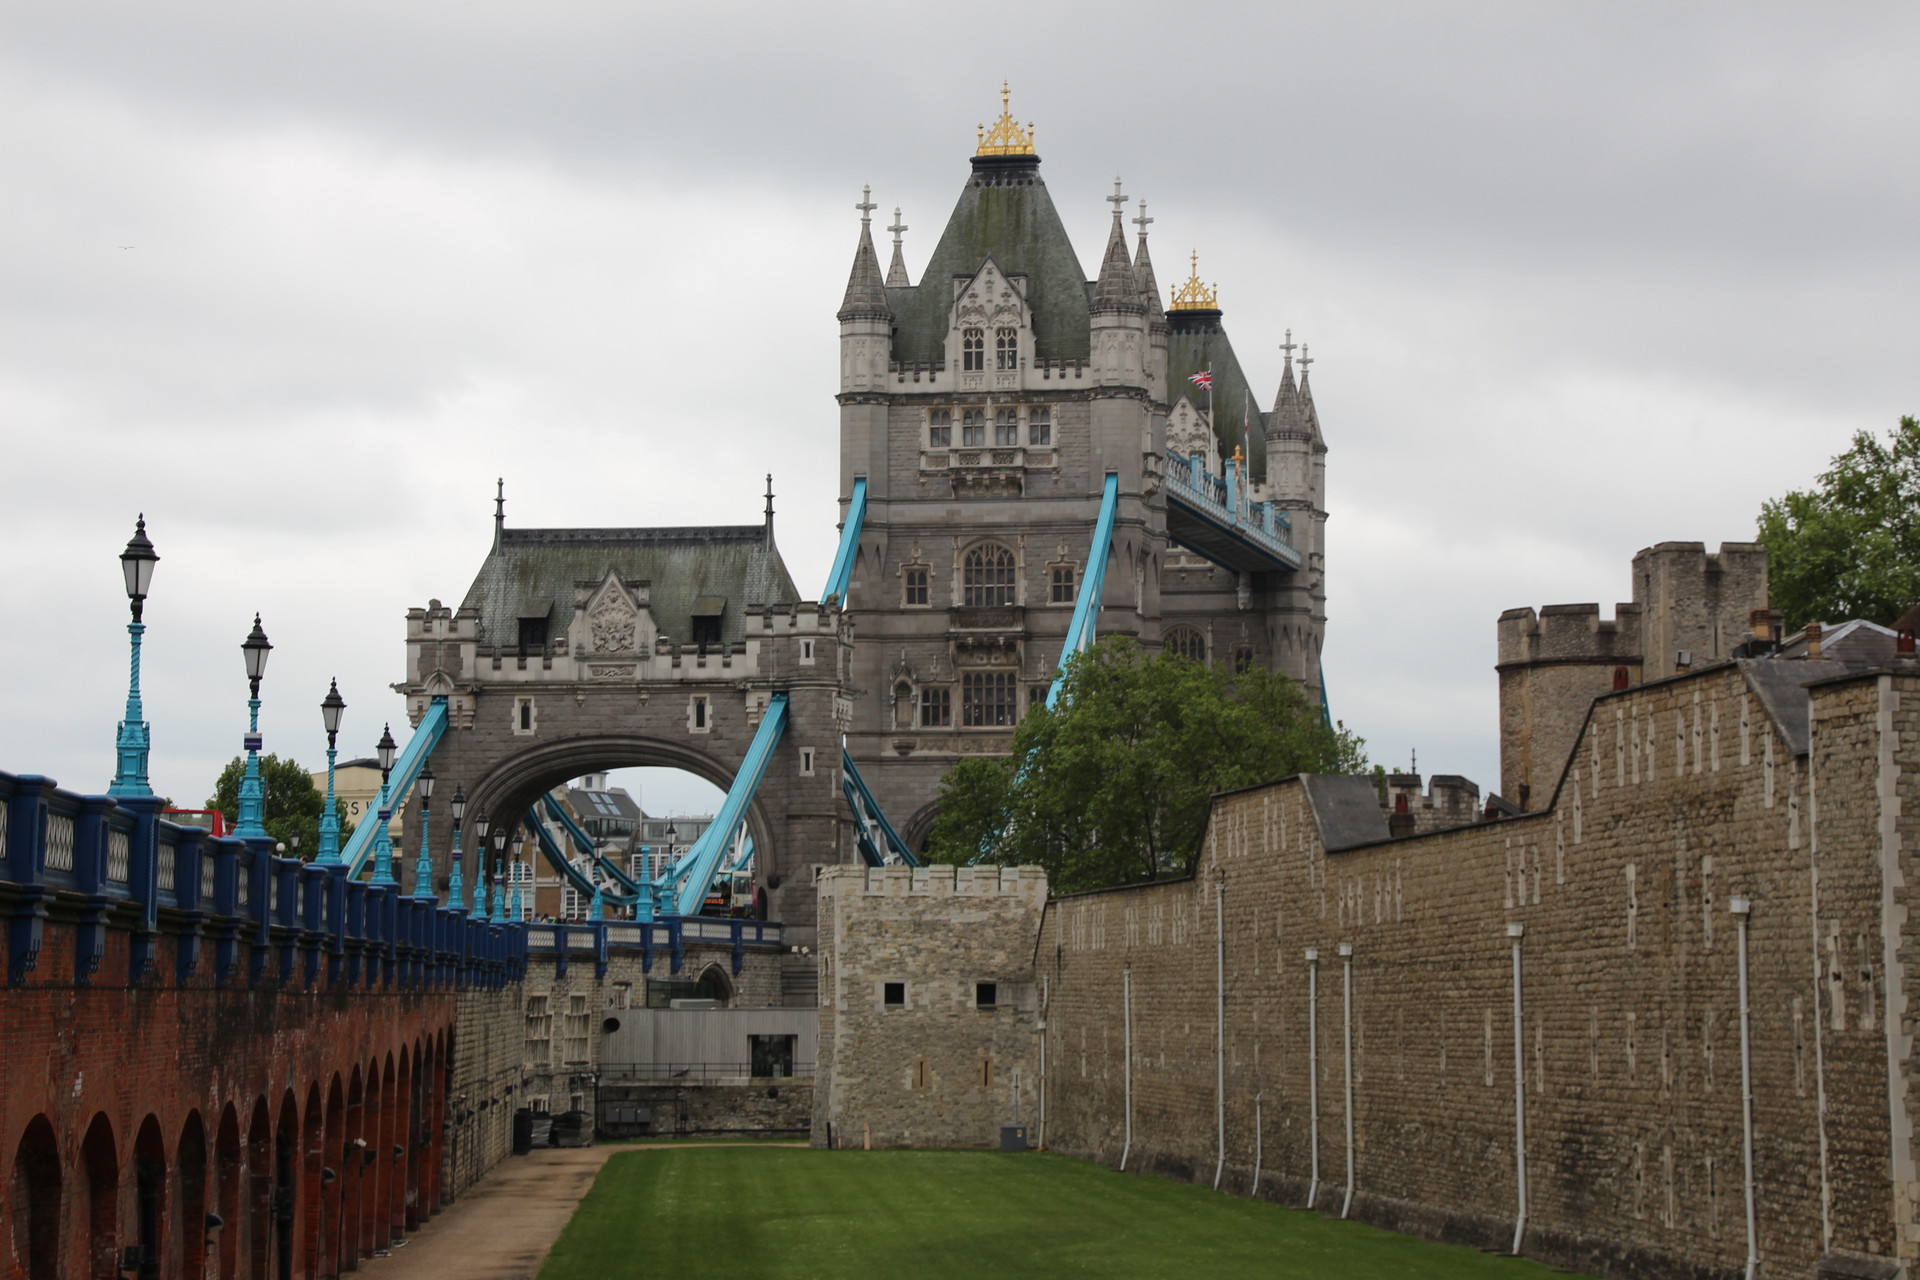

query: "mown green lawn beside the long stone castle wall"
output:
540 1148 1582 1280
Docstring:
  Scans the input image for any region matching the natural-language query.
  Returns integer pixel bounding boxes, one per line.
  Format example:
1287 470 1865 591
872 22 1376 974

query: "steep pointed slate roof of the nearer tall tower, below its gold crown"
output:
889 155 1091 363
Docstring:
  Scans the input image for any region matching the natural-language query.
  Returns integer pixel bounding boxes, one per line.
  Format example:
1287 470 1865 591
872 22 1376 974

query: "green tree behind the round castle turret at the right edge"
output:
1759 416 1920 629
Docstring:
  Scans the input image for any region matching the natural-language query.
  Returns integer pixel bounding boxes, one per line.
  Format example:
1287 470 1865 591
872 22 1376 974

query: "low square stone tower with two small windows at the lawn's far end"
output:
812 867 1046 1148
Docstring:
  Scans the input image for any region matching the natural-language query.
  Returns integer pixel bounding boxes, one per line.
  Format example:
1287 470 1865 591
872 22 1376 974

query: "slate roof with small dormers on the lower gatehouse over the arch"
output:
461 524 801 647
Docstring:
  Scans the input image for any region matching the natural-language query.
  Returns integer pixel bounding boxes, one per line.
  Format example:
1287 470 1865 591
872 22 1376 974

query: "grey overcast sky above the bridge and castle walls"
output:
0 0 1920 810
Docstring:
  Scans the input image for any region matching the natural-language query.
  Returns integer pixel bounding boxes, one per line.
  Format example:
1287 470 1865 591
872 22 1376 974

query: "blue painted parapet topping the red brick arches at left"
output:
0 773 526 990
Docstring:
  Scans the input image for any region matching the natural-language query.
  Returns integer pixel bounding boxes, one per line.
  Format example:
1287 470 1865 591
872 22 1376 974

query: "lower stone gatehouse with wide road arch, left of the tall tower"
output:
396 501 852 940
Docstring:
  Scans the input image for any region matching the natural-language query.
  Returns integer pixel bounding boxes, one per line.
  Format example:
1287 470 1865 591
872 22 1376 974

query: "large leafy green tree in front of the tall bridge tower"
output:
927 637 1367 892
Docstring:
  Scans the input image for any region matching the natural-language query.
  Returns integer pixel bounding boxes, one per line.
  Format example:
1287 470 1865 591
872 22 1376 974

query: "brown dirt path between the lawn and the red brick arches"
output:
359 1142 804 1280
